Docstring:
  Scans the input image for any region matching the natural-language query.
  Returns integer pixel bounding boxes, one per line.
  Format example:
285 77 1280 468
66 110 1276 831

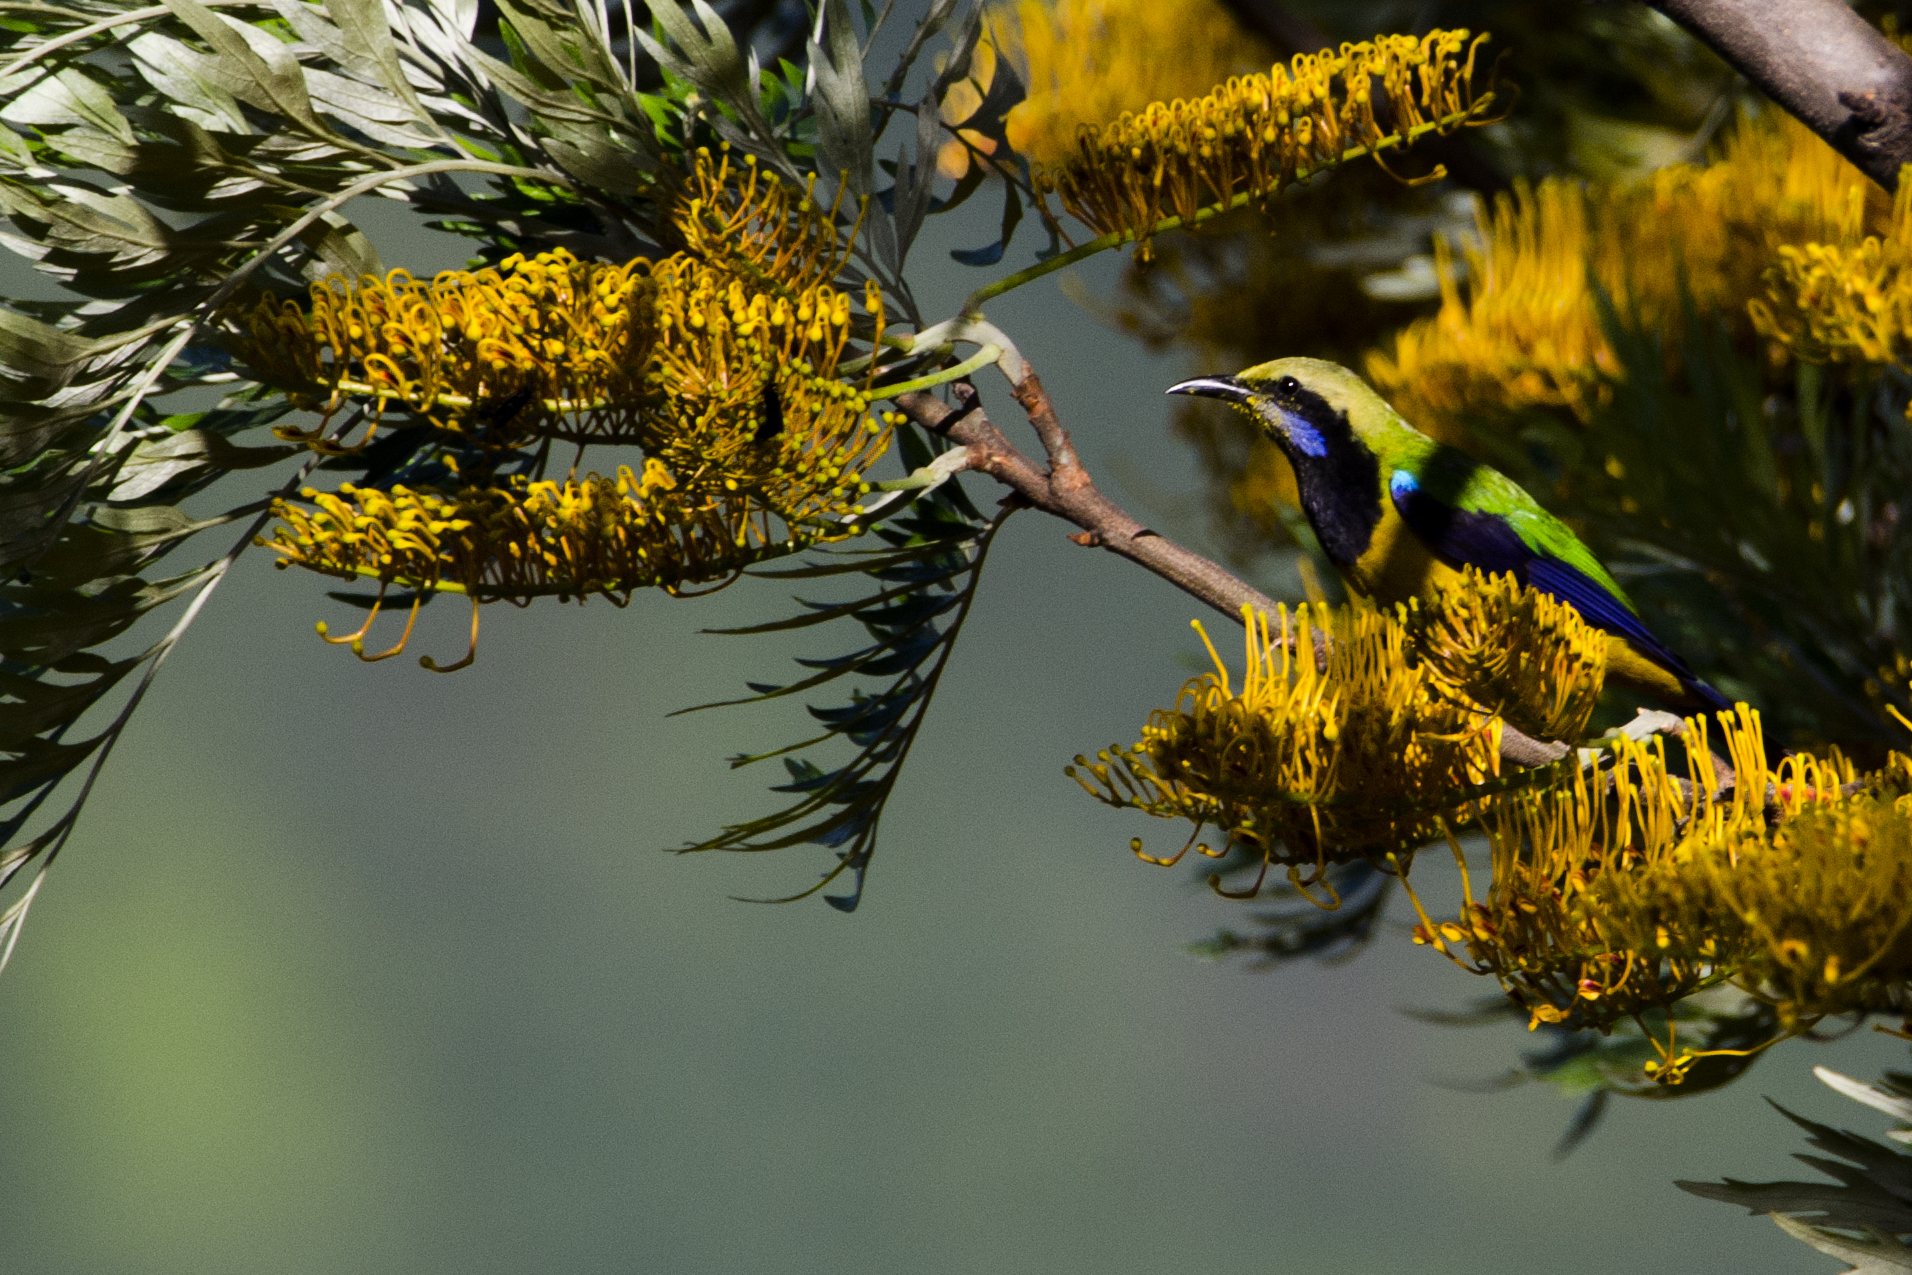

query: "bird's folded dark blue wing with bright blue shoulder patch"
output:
1388 470 1732 709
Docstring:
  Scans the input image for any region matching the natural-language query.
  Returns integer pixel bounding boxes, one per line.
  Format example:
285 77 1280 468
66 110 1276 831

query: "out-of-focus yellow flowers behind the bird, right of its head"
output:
1367 111 1891 428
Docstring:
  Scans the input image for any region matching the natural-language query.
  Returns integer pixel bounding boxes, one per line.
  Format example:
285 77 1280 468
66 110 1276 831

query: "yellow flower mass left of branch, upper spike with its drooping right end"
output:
228 246 891 535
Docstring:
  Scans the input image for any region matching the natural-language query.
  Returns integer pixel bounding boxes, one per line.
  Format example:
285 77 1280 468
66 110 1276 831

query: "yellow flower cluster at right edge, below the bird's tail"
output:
1415 705 1912 1082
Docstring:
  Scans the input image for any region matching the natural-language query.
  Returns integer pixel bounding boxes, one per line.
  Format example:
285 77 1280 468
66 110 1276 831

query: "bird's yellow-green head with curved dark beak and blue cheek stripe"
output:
1168 359 1398 463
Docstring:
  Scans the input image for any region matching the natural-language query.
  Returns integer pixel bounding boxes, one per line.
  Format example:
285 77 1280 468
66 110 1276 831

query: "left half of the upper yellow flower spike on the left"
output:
226 249 656 453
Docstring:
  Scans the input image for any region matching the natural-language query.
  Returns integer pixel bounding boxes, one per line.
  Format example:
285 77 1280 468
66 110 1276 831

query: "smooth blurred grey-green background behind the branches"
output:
0 6 1904 1275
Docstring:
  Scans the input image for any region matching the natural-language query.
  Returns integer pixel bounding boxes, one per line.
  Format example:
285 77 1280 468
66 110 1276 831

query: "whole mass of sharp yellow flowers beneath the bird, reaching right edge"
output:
1069 572 1912 1084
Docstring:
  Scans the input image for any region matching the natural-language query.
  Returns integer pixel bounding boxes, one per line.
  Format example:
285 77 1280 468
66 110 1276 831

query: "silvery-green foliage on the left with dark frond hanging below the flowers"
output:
0 0 1047 936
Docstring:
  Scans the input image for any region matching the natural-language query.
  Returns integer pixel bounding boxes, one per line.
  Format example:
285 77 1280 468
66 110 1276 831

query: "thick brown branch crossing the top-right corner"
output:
1648 0 1912 191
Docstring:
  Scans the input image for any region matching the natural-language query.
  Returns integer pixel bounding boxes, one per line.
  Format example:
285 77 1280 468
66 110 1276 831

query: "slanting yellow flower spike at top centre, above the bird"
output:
1034 31 1493 247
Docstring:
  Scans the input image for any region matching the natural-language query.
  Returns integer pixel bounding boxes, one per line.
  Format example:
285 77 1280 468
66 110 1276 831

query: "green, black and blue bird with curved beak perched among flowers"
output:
1168 357 1732 711
